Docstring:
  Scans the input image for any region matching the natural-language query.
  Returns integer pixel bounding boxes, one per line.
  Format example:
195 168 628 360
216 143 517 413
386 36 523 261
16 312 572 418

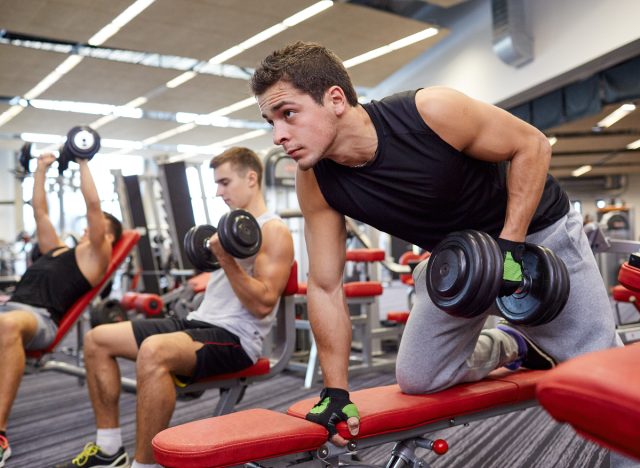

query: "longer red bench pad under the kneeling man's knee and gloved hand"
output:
288 371 543 438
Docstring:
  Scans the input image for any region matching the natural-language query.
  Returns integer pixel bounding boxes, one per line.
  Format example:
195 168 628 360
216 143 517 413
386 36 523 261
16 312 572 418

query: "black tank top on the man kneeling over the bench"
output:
314 91 569 250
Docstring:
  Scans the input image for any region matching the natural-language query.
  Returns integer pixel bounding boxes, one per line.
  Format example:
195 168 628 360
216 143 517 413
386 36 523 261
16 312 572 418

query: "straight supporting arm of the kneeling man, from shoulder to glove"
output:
296 170 351 390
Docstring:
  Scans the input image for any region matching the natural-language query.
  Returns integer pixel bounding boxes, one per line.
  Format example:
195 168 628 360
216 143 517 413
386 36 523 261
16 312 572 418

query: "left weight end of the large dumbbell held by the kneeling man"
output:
426 231 502 318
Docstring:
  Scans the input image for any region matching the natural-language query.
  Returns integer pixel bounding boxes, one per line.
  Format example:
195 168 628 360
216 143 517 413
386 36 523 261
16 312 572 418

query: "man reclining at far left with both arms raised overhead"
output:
0 153 122 467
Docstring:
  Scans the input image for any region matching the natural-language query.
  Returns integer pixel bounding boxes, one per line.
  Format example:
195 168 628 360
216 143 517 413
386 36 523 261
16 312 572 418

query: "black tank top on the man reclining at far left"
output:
11 248 91 323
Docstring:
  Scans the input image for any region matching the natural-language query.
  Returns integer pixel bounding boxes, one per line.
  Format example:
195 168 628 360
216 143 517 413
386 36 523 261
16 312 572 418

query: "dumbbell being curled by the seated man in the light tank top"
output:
184 210 262 271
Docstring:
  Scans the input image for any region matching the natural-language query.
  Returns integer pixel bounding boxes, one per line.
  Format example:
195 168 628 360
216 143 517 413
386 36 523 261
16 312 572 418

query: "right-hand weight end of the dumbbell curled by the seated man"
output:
218 210 262 258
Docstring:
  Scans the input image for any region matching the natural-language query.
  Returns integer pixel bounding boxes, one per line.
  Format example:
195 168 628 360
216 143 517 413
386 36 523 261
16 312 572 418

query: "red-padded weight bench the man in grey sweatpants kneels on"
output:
152 369 546 468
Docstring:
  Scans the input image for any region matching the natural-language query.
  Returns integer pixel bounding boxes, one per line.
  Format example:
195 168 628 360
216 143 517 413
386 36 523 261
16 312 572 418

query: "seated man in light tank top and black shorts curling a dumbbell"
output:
59 148 293 467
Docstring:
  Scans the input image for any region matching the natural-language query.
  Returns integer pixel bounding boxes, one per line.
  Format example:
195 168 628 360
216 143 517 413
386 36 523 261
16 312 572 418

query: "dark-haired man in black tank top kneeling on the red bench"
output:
251 42 619 454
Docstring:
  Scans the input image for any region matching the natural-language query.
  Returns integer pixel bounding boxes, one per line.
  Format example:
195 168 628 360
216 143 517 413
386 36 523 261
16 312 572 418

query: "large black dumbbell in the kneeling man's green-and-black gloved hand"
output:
426 230 570 326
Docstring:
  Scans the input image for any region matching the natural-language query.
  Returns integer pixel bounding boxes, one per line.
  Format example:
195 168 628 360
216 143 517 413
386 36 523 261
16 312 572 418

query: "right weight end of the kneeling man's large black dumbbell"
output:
496 244 569 326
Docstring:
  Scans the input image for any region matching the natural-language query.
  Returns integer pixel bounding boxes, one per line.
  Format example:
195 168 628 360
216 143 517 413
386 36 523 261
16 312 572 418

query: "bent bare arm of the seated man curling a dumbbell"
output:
214 221 293 318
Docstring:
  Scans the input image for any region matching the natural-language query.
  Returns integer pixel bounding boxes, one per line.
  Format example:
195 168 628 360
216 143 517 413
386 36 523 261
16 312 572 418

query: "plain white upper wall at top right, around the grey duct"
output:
371 0 640 104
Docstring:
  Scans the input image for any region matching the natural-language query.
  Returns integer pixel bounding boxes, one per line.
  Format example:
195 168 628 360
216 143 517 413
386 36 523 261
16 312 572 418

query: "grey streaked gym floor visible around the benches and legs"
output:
7 283 608 468
